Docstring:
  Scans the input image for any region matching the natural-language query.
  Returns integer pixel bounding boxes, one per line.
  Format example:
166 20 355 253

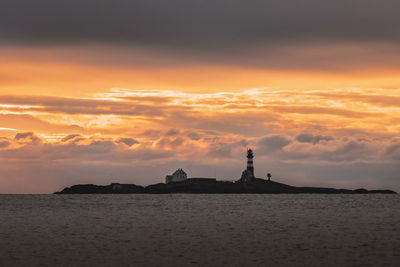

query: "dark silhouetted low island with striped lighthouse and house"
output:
55 149 397 194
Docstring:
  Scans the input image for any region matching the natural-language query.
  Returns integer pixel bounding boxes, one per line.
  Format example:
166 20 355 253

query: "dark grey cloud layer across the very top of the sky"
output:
0 0 400 50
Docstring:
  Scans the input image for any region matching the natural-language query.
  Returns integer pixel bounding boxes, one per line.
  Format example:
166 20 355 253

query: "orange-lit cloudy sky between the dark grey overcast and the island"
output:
0 46 400 192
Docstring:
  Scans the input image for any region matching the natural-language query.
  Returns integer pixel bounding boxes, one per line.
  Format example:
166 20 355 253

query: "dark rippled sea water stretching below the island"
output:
0 194 400 266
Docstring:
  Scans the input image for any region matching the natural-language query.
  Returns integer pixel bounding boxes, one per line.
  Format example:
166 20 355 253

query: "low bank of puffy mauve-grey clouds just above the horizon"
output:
0 131 400 193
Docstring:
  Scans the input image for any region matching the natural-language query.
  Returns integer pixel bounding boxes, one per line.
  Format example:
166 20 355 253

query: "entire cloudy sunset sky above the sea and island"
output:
0 0 400 194
